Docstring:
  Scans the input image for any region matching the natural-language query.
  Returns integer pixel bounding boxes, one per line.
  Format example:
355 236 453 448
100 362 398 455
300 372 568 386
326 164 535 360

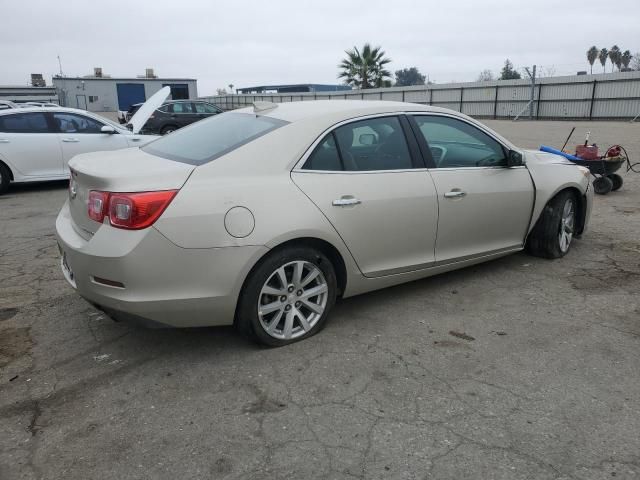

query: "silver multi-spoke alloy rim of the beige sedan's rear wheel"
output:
258 260 329 340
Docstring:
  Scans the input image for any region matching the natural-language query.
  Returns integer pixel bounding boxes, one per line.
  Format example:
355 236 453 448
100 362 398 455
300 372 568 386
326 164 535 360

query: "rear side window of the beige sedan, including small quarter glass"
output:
302 117 413 171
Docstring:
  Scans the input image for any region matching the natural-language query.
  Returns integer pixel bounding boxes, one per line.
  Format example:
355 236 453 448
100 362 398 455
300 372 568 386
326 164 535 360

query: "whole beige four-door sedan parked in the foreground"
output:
56 100 593 346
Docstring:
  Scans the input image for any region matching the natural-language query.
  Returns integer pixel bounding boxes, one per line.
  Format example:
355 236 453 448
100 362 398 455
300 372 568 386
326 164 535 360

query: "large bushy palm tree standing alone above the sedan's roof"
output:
338 43 391 88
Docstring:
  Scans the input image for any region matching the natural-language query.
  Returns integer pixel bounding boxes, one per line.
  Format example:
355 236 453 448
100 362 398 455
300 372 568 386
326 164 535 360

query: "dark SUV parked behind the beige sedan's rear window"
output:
142 100 222 135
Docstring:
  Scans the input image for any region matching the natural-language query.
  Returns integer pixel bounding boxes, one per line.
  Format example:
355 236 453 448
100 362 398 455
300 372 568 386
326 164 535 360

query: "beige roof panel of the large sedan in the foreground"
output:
236 100 451 122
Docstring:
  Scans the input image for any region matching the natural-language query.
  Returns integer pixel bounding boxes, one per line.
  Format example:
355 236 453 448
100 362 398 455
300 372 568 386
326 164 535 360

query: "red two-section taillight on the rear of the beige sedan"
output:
89 190 178 230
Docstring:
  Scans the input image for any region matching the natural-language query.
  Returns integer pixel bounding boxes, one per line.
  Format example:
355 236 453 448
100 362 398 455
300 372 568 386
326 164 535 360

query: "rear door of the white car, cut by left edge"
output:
0 112 64 178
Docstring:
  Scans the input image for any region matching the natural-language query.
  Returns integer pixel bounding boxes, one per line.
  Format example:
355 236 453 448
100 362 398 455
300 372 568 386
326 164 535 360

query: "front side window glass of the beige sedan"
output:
414 115 506 168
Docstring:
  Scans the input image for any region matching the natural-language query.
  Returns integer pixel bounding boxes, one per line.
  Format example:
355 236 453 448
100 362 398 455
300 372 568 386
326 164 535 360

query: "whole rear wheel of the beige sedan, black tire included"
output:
236 247 337 347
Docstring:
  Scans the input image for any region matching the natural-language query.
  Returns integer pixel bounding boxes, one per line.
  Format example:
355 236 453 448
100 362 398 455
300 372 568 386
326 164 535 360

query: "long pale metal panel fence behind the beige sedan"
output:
202 72 640 120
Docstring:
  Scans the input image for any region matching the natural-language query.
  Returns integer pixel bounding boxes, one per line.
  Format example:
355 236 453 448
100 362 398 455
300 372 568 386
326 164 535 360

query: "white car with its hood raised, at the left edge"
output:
0 87 169 194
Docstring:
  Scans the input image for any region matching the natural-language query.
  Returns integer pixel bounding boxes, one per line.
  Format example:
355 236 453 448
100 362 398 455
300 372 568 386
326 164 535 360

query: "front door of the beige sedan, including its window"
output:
413 115 534 263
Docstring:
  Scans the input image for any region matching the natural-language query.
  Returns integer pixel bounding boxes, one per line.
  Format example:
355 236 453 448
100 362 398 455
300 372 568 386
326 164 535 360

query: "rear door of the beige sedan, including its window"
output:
292 116 438 277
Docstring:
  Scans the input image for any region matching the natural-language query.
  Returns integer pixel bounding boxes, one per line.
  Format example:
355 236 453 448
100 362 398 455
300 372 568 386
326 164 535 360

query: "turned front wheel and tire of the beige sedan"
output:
527 190 578 258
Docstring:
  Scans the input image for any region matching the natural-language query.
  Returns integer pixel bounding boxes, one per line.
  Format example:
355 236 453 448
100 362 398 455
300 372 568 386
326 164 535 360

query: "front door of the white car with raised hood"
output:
53 112 128 172
